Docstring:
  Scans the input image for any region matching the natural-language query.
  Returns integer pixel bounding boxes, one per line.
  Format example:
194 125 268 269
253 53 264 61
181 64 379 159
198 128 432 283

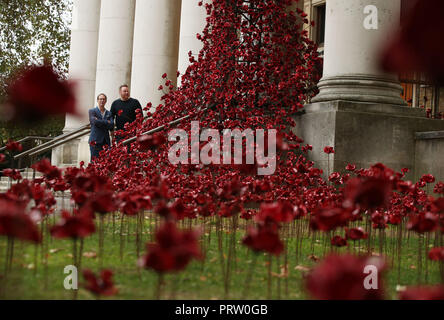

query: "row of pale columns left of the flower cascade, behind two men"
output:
52 0 206 165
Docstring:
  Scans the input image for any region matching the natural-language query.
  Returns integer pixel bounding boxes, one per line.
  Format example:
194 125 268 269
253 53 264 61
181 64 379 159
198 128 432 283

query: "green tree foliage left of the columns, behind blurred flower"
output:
0 0 72 141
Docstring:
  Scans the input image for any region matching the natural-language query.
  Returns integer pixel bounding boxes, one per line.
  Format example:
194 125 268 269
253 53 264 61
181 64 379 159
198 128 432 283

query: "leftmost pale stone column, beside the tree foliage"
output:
64 0 100 131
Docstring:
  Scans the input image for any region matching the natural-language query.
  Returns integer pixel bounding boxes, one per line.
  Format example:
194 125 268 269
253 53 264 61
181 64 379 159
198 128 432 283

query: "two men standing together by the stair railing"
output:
89 84 142 161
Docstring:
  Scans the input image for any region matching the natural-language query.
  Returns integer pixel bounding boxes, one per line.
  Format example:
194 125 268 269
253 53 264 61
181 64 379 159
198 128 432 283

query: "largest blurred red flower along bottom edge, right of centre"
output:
306 254 385 300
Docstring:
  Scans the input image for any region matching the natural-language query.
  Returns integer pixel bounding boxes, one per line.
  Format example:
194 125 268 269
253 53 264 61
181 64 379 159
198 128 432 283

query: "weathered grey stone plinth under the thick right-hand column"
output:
294 100 444 180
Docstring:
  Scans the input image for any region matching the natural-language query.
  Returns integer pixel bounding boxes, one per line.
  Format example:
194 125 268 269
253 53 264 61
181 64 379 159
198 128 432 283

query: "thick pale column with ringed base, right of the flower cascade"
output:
312 0 406 105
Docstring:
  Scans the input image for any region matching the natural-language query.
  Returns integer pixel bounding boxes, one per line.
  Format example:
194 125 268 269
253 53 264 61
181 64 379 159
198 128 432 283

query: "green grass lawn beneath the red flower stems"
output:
0 215 441 299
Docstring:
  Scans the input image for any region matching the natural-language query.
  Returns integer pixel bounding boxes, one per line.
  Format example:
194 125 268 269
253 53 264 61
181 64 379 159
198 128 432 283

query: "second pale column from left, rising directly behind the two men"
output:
95 0 134 101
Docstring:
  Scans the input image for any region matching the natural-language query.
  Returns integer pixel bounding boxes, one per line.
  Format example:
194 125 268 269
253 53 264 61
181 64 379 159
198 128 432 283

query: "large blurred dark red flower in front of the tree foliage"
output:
8 65 76 122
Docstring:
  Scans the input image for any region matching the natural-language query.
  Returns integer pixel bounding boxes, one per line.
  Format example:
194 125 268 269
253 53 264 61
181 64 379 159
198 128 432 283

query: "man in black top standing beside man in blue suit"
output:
110 84 142 142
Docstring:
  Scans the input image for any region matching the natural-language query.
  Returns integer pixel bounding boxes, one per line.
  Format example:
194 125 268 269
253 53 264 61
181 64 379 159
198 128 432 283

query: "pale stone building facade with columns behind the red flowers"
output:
53 0 444 182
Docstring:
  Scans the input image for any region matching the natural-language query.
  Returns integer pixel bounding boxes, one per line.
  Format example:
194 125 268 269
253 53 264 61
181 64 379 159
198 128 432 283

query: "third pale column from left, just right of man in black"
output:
131 0 181 108
